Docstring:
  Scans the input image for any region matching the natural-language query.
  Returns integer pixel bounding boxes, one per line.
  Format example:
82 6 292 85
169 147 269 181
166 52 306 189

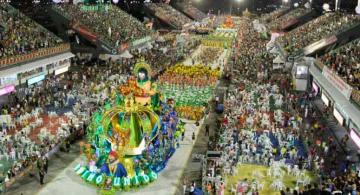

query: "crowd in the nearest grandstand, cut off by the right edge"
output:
321 39 360 90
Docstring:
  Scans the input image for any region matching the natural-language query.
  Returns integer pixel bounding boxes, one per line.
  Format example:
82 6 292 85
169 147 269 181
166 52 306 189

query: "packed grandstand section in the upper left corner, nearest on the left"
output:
0 3 70 66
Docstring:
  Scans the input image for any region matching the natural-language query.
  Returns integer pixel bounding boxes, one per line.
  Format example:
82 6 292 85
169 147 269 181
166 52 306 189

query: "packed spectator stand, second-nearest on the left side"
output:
52 3 153 55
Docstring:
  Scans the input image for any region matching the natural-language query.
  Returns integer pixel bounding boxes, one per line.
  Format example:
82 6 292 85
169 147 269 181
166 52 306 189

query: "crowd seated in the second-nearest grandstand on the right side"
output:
280 13 360 53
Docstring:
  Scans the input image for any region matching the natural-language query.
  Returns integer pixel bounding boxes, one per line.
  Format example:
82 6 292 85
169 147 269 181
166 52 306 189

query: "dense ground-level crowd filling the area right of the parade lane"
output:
203 16 360 195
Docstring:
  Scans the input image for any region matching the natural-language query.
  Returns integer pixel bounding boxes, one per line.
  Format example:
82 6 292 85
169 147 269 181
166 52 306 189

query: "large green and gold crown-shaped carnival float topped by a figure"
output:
74 60 184 194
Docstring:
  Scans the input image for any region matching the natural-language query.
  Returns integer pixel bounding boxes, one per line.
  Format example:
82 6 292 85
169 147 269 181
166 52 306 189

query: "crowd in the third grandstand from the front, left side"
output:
146 3 191 29
